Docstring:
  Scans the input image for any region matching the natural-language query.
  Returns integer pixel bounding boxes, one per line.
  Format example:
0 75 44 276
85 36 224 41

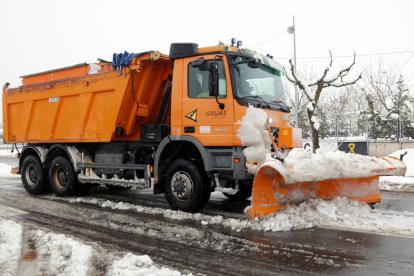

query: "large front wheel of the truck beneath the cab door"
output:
165 159 211 212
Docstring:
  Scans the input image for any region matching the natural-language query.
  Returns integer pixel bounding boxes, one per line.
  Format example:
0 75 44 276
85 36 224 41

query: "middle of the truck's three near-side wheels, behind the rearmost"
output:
49 156 78 197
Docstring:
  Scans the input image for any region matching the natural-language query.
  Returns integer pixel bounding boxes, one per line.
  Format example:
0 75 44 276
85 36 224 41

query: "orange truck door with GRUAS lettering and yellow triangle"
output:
182 55 234 146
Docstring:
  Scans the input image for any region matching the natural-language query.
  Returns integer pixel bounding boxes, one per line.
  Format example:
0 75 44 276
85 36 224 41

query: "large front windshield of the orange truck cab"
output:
231 56 289 112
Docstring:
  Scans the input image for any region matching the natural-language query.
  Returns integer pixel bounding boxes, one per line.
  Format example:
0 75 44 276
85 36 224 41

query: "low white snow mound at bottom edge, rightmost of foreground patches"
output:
106 253 181 276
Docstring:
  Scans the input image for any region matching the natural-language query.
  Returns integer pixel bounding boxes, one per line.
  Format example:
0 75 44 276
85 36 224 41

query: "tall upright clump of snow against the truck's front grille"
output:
237 106 272 170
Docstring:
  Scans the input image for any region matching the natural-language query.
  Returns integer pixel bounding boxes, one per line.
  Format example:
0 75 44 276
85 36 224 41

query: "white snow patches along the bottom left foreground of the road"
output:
0 218 186 276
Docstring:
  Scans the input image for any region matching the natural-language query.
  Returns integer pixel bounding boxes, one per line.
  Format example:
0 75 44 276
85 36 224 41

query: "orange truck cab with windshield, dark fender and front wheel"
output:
155 43 301 210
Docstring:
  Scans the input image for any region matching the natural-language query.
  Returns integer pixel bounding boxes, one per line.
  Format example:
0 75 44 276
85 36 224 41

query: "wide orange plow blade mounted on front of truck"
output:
245 157 406 218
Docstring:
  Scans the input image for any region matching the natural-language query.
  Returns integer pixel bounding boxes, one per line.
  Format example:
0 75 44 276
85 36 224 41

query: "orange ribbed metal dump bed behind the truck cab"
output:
3 52 171 143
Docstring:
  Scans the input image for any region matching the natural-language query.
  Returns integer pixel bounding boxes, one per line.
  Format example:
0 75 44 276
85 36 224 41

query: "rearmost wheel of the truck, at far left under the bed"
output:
21 155 44 195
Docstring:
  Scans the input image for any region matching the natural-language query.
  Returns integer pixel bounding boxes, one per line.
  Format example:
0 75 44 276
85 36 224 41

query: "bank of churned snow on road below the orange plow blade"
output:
259 198 414 236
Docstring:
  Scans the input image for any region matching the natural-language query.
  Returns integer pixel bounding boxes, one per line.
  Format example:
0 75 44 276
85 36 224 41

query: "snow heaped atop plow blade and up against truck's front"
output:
237 106 401 183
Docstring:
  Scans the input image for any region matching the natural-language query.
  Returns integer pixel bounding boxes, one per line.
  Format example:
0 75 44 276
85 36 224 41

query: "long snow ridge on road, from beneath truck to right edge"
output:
63 195 414 237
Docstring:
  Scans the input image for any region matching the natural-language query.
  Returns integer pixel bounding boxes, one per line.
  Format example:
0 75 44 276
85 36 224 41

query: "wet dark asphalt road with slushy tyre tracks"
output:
0 155 414 275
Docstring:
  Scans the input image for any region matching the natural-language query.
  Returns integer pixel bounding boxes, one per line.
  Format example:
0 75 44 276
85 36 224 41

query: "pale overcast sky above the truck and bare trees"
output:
0 0 414 94
